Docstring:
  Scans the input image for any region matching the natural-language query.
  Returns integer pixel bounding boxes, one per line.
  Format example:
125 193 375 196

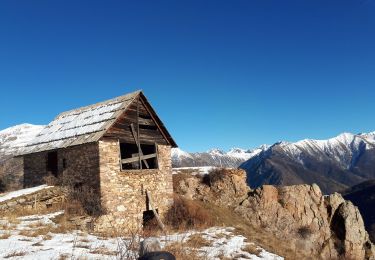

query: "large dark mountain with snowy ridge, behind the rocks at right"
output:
240 133 375 193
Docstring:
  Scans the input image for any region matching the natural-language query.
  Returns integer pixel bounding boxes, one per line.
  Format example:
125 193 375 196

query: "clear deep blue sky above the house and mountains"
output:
0 0 375 151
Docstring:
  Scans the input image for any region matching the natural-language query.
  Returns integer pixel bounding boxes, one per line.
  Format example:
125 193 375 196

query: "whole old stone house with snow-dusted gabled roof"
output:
16 91 176 230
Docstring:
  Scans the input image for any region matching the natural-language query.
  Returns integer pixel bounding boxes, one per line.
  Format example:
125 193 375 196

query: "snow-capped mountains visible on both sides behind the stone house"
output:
0 124 375 194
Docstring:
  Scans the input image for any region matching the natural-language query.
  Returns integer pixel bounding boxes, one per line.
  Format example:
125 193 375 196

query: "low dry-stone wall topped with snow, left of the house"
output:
0 187 65 214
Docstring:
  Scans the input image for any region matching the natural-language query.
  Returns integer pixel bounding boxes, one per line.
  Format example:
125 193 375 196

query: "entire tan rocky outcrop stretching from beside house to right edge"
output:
175 170 374 259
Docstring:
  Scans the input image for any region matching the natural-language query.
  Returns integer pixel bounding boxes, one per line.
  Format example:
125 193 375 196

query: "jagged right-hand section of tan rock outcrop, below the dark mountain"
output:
239 184 374 259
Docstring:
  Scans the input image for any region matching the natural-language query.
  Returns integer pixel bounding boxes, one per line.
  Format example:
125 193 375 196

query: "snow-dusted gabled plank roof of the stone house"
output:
19 90 177 155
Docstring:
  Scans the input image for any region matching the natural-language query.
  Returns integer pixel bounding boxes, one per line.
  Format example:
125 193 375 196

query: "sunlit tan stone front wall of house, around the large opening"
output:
97 138 173 231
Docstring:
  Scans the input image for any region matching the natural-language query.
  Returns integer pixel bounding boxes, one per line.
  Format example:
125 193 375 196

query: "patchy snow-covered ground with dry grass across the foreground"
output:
0 211 283 260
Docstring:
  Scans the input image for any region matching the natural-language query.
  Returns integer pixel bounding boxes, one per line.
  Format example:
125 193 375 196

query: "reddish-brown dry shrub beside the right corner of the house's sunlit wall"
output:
166 196 213 229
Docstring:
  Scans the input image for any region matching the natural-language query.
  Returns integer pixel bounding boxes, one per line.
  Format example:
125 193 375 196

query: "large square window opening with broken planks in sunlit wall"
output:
120 143 158 170
